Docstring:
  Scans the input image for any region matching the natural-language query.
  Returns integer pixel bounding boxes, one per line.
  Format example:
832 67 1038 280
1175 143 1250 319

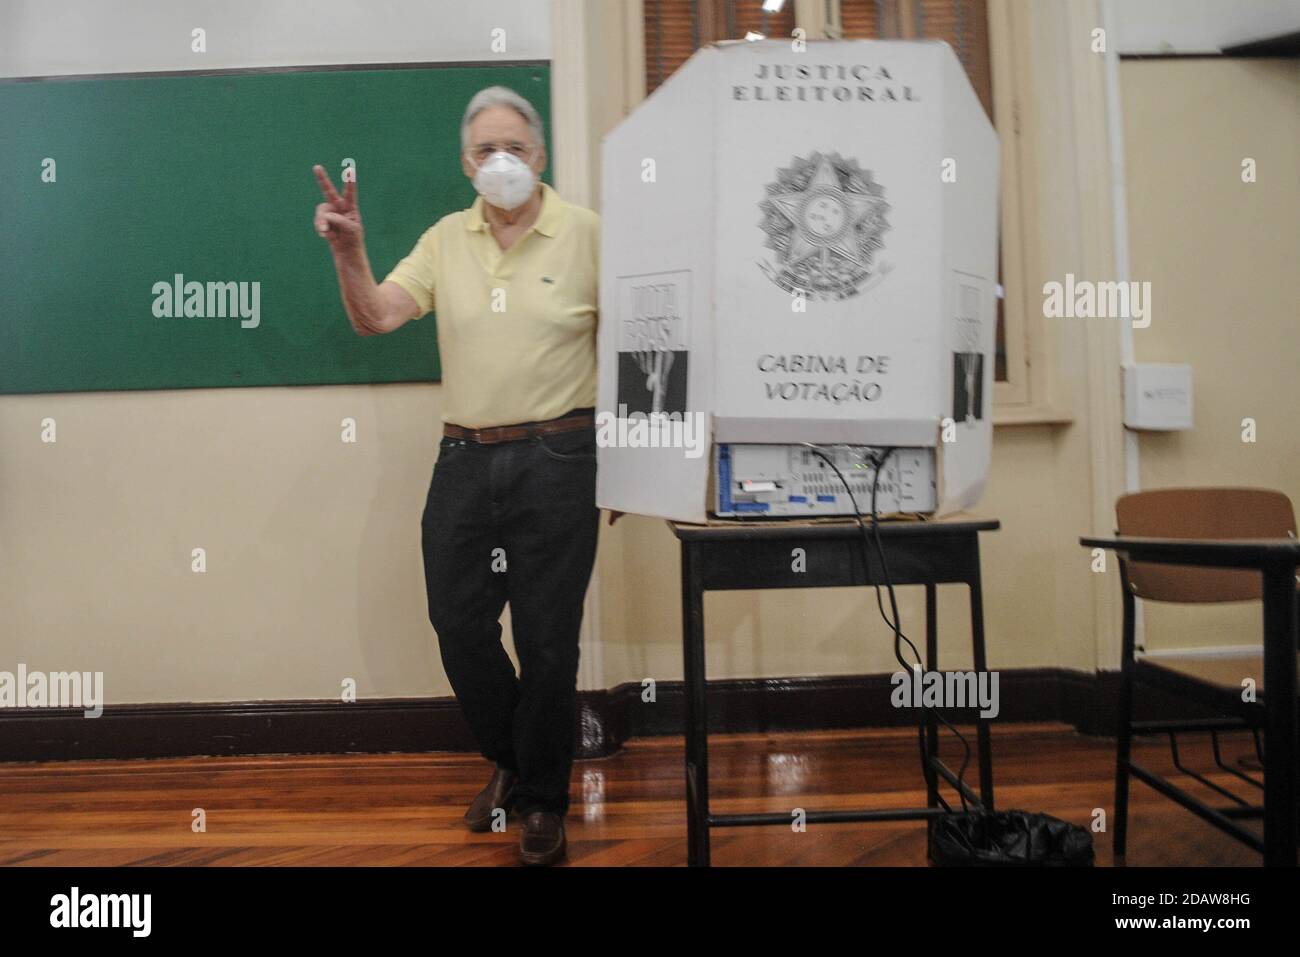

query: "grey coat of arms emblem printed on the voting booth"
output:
758 152 889 299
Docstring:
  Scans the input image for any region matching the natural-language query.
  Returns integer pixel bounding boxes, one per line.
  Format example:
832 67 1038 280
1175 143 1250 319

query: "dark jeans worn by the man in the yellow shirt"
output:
423 416 599 815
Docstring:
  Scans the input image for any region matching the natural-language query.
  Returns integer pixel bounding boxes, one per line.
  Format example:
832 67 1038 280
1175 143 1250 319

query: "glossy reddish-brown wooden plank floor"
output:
0 724 1260 866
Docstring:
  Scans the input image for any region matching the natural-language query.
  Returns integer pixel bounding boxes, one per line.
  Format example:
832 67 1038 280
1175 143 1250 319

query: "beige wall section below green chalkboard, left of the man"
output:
0 384 450 703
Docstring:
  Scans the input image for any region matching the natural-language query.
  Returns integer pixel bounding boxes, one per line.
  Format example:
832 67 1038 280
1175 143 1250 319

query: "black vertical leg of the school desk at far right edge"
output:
1264 566 1297 867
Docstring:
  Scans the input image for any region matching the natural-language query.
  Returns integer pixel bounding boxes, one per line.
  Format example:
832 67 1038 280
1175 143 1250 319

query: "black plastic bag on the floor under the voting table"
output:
930 811 1093 867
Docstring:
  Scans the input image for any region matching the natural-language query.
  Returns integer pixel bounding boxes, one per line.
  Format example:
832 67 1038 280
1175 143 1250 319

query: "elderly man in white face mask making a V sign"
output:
315 87 599 865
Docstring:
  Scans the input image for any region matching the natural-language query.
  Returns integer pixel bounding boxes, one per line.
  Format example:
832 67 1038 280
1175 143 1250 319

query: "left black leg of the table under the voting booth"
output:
681 542 710 867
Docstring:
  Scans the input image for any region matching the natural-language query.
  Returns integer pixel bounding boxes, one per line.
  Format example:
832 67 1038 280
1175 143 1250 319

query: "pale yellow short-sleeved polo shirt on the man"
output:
385 183 601 429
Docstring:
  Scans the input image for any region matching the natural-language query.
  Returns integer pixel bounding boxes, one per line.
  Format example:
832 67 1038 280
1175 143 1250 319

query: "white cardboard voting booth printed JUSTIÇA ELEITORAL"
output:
597 40 998 521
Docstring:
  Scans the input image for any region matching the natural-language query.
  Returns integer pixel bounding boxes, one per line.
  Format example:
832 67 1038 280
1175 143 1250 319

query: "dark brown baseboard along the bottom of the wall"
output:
0 668 1205 762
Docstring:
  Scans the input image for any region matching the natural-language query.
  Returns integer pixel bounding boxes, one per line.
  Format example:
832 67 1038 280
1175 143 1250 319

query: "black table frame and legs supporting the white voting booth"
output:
670 519 1000 866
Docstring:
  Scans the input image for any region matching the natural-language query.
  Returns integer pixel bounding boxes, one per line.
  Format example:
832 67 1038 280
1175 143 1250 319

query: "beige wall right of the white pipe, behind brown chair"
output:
1122 59 1300 649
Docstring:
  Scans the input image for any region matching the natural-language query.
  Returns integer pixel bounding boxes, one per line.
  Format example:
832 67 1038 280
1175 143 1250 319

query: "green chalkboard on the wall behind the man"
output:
0 64 550 393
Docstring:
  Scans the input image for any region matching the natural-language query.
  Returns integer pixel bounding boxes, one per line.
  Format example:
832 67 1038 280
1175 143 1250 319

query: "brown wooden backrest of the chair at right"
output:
1115 489 1296 602
